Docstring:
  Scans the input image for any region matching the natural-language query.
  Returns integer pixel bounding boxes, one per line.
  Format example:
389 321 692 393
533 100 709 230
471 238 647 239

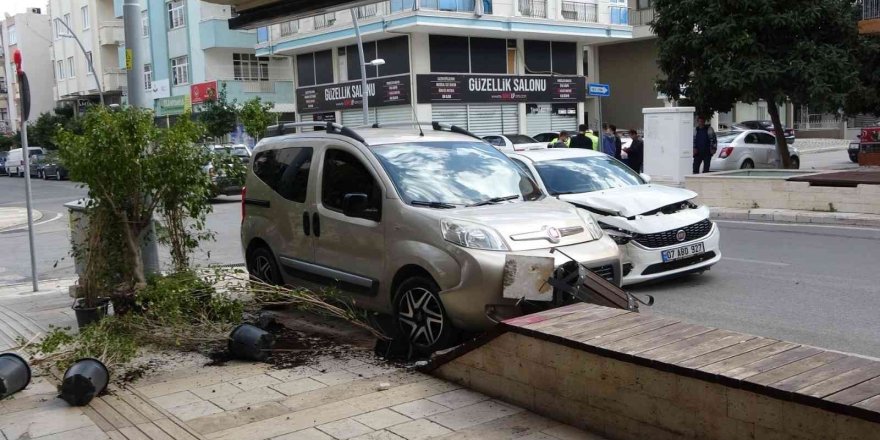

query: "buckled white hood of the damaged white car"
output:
559 185 697 217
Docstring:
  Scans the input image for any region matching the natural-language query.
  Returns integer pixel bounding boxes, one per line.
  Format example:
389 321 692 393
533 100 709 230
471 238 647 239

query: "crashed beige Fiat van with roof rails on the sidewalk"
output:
241 123 620 350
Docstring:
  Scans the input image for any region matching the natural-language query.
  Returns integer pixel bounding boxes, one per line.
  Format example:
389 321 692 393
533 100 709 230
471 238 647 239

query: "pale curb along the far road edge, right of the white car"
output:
710 208 880 229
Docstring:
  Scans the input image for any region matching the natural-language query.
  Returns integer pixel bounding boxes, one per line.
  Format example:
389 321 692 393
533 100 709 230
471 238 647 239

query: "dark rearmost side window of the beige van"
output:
253 147 314 203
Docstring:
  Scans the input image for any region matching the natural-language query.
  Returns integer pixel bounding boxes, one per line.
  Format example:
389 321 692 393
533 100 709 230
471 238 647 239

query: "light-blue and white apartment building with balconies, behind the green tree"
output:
129 0 294 123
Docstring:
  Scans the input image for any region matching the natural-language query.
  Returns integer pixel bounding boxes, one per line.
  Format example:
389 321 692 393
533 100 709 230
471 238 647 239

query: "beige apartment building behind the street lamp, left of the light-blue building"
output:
49 0 126 107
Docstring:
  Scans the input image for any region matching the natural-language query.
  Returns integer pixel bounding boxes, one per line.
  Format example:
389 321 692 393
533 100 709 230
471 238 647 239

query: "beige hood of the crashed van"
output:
417 198 599 251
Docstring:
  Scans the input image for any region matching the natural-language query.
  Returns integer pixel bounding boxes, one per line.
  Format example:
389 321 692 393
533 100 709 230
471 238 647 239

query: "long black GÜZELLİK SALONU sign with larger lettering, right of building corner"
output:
416 74 587 104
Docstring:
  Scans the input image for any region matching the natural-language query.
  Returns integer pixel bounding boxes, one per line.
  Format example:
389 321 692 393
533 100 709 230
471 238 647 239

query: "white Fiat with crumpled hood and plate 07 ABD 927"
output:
507 148 721 285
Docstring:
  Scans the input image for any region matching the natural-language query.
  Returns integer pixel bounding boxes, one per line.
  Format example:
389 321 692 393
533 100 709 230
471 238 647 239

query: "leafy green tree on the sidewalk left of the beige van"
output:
57 107 209 291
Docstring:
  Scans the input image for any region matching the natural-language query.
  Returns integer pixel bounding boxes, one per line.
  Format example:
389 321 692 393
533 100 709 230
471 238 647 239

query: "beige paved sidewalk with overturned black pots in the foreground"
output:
0 280 601 440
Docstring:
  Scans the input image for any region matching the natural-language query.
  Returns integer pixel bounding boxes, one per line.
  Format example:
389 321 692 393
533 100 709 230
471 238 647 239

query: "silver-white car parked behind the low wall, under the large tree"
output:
710 130 801 171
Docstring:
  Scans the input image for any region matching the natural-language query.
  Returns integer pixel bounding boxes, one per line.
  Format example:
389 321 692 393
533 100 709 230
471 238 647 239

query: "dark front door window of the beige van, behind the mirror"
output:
321 149 382 220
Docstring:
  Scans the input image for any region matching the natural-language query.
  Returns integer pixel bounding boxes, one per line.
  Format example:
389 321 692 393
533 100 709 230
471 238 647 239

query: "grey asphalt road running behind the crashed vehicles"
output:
0 177 880 357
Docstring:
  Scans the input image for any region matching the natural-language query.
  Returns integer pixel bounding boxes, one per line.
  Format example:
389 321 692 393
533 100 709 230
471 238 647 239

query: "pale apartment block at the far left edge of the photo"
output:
0 8 55 131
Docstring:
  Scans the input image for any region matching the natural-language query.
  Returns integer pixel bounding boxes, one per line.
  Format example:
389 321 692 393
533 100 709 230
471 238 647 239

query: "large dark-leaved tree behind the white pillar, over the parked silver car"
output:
652 0 858 168
